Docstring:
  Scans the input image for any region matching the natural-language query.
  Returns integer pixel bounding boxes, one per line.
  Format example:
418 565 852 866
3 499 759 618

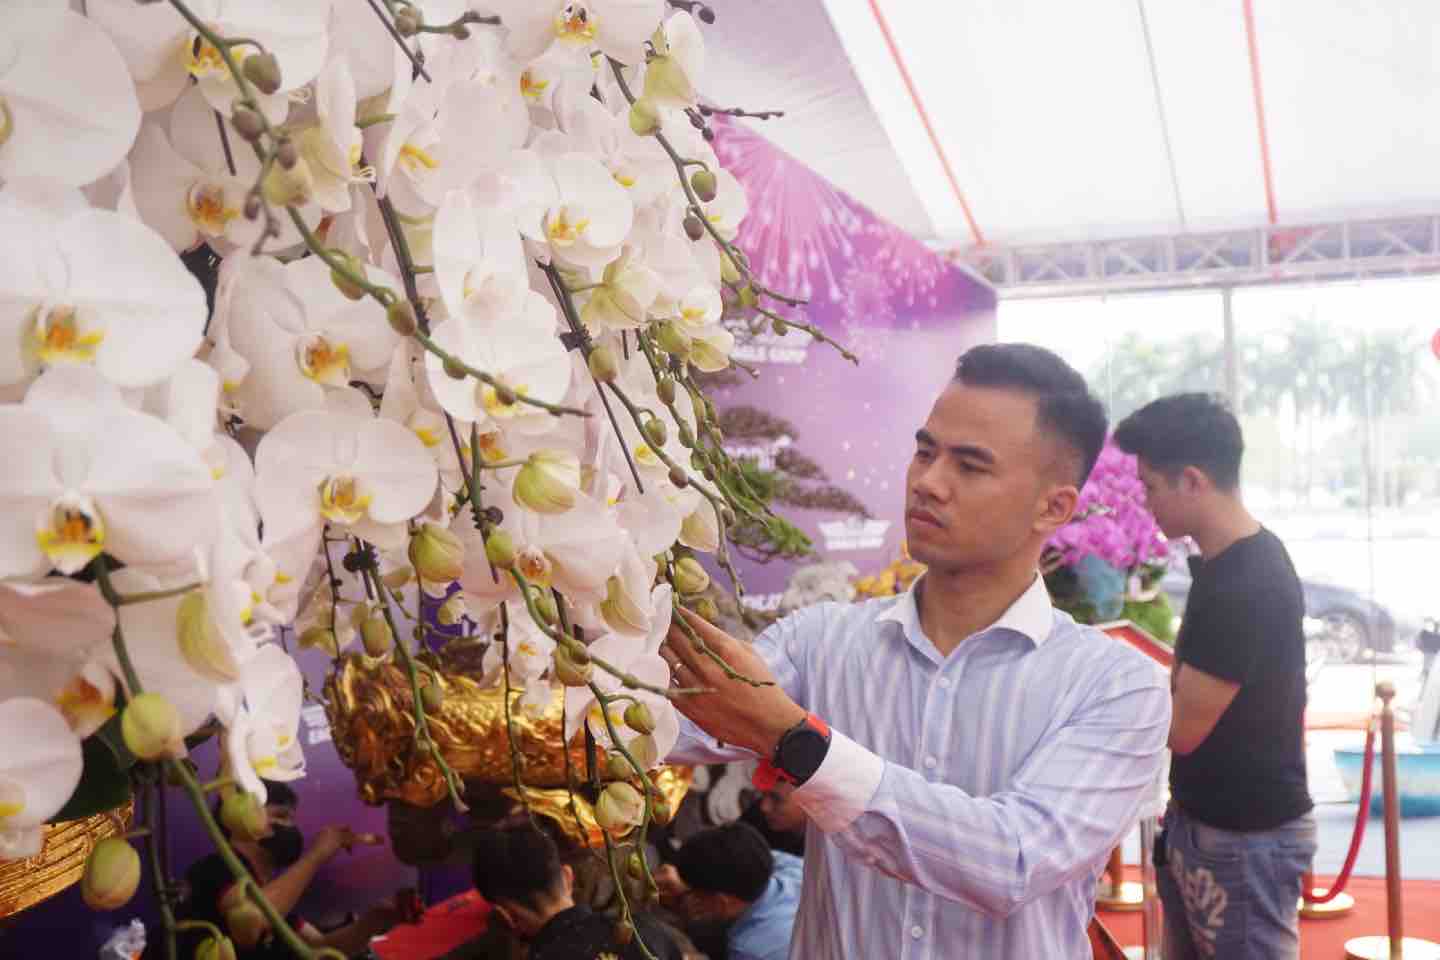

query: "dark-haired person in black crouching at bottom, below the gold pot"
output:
445 823 683 960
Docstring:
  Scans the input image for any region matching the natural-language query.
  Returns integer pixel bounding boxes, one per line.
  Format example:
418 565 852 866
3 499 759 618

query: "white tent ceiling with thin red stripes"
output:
707 0 1440 249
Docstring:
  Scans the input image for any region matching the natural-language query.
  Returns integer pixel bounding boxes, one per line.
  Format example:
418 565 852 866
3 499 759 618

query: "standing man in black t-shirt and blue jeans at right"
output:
1115 393 1315 960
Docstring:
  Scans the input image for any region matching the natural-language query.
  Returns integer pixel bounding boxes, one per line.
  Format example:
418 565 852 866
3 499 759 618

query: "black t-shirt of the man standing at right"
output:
1171 530 1313 830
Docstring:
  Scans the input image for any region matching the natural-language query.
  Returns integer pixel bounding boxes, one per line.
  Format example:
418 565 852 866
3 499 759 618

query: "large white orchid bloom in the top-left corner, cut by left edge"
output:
0 0 140 188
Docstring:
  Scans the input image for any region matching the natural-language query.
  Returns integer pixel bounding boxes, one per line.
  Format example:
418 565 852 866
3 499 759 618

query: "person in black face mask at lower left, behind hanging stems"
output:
172 782 400 960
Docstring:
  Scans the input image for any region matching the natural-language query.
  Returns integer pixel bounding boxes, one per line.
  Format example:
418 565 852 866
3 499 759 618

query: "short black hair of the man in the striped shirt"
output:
955 344 1109 486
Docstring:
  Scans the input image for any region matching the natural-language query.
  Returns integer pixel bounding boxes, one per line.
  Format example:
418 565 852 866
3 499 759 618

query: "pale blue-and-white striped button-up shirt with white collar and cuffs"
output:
671 577 1171 960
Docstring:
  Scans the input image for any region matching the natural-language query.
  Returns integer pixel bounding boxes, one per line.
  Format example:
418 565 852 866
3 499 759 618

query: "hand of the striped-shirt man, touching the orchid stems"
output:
660 609 805 759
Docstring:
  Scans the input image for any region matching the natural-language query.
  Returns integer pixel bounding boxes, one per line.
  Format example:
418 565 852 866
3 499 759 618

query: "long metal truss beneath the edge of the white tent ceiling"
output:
952 216 1440 299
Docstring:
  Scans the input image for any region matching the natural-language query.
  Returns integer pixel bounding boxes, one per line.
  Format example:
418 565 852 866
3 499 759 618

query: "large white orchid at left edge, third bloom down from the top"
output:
0 367 219 577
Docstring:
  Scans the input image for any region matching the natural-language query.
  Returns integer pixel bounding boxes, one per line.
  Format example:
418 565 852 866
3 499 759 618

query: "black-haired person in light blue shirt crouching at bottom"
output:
657 823 805 960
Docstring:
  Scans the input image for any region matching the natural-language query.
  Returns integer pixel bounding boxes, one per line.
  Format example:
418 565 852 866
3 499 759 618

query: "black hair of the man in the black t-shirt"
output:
1115 393 1246 491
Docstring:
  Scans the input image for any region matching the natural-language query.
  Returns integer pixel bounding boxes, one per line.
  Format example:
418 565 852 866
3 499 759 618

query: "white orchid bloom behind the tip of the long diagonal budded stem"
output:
425 289 572 433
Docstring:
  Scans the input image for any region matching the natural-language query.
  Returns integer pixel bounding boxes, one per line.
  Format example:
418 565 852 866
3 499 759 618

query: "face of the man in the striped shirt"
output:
904 383 1074 571
